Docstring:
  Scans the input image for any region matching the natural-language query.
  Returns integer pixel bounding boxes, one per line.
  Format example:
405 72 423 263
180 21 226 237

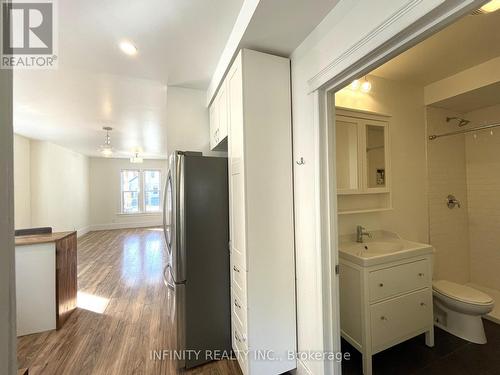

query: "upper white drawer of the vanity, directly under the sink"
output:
368 259 430 302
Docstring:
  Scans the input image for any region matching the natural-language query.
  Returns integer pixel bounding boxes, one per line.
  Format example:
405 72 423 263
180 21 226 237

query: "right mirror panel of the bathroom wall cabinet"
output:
366 125 387 188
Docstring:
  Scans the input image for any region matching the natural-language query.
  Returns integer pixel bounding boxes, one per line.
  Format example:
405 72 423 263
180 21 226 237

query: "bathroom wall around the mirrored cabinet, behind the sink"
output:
335 76 429 242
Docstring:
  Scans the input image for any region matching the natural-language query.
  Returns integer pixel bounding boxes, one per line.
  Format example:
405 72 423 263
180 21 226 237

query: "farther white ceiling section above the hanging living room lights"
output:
14 69 167 158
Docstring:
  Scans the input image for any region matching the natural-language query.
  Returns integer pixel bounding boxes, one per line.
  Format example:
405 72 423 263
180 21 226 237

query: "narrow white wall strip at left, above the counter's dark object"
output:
14 134 31 229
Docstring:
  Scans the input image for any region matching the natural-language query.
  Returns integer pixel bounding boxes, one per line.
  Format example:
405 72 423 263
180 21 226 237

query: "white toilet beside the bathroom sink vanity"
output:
432 280 495 344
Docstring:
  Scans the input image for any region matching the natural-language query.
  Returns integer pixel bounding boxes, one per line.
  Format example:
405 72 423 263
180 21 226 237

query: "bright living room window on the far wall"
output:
121 169 161 214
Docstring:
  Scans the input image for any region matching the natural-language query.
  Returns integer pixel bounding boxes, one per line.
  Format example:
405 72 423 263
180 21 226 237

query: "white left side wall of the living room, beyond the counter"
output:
30 140 89 235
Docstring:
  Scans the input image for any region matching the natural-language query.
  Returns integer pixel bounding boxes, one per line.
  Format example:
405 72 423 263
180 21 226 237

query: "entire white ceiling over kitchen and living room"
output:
14 0 243 157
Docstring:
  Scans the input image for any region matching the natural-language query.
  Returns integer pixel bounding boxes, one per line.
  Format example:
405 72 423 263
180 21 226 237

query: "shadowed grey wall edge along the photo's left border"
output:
0 60 17 375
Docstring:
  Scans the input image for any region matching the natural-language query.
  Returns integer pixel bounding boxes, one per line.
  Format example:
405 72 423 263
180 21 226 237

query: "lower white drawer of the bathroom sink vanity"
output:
370 288 433 352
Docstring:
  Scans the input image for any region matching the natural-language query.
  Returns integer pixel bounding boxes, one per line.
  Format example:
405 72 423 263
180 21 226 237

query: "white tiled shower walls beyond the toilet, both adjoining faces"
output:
427 105 500 290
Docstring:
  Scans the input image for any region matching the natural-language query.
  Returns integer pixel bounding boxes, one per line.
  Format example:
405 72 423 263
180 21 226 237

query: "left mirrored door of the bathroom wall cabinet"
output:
335 118 358 190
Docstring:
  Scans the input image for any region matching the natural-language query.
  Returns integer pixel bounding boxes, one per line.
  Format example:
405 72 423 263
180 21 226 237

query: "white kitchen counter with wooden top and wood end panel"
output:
15 231 77 336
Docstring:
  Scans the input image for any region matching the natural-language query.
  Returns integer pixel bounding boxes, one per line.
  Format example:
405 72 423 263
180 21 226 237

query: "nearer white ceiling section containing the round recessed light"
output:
58 0 243 89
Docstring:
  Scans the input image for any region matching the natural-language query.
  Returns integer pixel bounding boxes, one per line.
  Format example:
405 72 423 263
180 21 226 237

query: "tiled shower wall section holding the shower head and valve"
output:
427 107 470 283
